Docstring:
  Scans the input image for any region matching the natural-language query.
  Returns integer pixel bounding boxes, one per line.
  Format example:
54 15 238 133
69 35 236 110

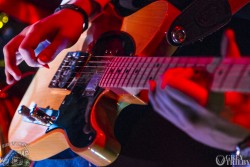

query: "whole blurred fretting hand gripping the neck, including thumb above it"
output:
149 31 250 151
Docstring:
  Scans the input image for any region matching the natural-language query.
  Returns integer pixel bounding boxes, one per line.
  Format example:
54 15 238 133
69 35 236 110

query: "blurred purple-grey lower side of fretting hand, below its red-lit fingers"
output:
149 86 250 151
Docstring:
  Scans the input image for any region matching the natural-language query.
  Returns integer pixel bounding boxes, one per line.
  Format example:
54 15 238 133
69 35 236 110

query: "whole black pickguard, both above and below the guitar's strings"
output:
47 31 135 148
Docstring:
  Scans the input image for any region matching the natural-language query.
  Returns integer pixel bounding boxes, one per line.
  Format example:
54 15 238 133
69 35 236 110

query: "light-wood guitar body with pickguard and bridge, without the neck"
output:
9 1 180 166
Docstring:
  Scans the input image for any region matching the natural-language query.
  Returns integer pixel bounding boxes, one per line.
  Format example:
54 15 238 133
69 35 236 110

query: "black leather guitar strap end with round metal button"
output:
167 0 232 46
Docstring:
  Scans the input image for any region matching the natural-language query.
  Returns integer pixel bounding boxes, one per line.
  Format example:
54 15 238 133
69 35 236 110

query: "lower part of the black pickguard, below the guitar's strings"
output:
48 87 103 148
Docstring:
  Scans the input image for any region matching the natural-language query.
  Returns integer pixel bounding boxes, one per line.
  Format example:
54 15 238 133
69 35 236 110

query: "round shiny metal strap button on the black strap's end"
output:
171 26 187 44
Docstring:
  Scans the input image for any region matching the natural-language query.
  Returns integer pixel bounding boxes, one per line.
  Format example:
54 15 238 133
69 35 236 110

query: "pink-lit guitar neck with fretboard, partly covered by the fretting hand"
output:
99 57 250 92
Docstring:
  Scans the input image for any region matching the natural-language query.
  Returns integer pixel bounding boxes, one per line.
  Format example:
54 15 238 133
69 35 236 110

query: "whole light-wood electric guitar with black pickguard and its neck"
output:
9 1 250 166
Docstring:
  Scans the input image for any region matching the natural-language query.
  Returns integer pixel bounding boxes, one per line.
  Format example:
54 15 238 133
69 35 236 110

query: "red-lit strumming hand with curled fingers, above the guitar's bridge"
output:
3 9 84 84
